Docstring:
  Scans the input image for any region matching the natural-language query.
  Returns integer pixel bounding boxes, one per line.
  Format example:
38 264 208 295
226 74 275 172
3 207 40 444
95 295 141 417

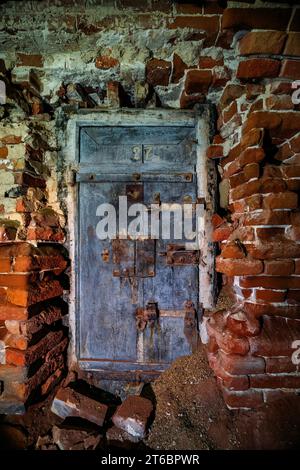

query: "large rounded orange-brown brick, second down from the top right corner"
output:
239 31 286 55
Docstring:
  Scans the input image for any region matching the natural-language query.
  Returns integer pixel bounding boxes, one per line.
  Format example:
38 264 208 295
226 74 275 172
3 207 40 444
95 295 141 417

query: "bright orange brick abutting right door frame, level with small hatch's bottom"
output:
216 256 263 276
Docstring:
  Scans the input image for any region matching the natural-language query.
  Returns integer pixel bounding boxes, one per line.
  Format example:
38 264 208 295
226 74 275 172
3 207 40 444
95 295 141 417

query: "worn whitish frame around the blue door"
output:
58 105 216 371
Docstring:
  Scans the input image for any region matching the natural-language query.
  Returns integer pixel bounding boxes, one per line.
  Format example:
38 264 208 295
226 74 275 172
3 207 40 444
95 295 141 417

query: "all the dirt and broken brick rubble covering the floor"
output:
0 350 300 450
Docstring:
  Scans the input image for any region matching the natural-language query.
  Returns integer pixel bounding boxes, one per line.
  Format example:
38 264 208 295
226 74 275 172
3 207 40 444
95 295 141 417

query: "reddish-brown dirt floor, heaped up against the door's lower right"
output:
0 351 300 450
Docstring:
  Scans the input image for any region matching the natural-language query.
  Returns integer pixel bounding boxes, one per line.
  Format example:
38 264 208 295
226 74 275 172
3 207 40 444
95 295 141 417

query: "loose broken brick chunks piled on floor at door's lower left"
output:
35 381 153 450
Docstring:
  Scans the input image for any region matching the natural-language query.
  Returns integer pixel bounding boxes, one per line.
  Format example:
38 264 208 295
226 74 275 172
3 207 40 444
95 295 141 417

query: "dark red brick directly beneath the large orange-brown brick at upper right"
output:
236 59 280 80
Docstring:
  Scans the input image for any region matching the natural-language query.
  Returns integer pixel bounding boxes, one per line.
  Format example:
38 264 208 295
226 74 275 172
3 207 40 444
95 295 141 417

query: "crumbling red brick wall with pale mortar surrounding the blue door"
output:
0 0 300 407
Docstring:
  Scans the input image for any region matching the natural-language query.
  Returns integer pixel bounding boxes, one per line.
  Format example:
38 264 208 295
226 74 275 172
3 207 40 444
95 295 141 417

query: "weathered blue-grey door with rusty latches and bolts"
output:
77 125 200 377
